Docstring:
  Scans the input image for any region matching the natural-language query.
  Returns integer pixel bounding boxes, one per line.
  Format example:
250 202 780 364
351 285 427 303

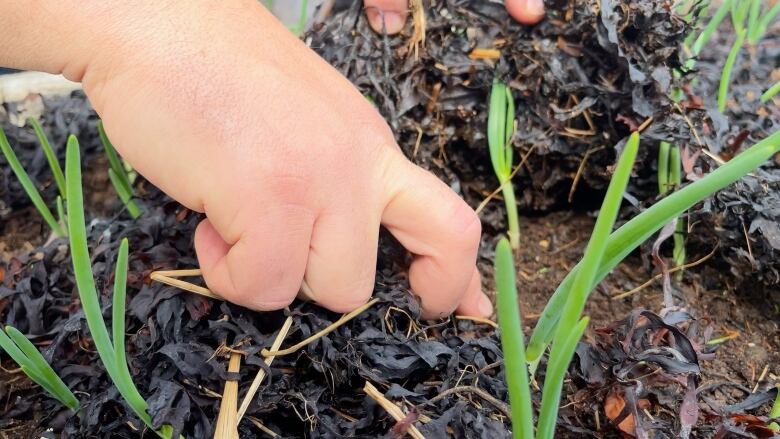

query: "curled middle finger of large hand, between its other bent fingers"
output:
305 208 379 312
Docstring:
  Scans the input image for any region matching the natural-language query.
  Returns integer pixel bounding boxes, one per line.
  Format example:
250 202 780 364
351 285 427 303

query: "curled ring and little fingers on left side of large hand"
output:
195 208 314 311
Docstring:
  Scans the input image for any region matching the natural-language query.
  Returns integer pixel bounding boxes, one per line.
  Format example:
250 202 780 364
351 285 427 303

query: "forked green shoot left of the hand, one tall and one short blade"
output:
65 136 171 438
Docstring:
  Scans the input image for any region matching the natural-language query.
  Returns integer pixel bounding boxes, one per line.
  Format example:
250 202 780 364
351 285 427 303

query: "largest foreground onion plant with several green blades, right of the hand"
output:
495 132 780 439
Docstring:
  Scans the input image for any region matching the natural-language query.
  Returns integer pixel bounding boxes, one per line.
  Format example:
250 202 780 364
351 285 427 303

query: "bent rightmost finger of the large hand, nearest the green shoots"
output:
382 157 486 318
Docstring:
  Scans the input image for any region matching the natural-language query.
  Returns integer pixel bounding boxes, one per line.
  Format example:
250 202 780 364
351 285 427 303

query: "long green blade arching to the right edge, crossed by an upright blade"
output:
526 132 780 364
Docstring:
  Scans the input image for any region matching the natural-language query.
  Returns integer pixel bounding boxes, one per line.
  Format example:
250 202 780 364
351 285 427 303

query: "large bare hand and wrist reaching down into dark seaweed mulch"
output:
0 0 544 318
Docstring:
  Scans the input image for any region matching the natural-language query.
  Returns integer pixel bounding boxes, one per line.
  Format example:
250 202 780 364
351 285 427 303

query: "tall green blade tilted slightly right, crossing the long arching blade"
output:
538 132 639 439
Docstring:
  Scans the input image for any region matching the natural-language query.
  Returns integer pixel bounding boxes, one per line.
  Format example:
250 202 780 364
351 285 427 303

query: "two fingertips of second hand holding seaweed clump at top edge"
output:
363 0 544 34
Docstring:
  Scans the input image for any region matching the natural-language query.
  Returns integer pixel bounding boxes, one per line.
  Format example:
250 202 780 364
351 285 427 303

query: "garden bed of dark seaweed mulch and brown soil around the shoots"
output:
0 0 780 438
